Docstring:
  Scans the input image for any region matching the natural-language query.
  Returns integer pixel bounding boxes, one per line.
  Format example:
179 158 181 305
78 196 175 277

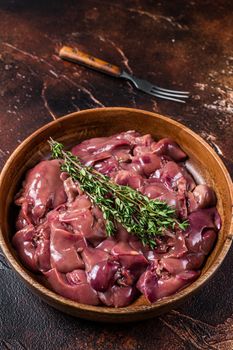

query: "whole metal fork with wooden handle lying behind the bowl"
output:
59 46 189 103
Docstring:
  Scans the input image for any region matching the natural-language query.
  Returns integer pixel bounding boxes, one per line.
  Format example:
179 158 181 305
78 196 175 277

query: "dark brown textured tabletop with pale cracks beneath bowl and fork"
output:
0 0 233 350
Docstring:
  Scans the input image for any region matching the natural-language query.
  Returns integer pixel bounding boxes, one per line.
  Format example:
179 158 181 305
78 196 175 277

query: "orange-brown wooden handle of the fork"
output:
59 46 121 77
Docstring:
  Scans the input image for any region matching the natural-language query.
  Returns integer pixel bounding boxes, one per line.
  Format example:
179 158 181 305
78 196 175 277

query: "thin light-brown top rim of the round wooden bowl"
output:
0 107 233 317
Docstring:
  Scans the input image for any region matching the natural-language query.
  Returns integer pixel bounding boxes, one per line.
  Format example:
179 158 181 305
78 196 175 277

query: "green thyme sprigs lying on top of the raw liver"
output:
49 139 188 248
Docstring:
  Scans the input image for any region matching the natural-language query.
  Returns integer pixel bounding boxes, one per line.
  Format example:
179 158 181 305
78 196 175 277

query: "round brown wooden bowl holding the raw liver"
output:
0 107 233 322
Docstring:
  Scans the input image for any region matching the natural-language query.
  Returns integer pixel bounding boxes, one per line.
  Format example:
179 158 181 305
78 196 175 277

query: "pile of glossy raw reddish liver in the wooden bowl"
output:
13 131 221 307
